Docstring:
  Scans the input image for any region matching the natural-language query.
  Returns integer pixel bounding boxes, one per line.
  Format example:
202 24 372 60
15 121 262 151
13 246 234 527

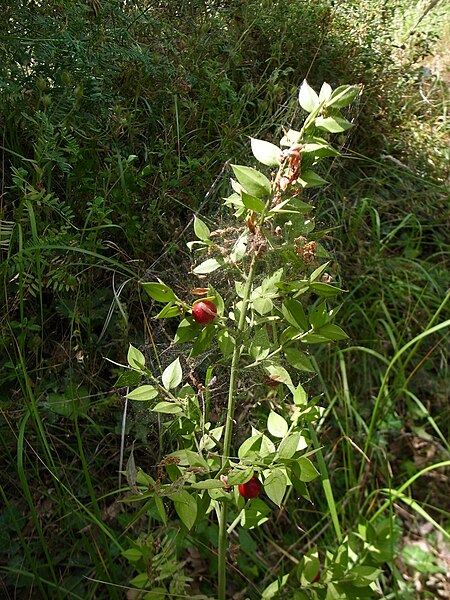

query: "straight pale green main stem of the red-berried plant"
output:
218 254 256 600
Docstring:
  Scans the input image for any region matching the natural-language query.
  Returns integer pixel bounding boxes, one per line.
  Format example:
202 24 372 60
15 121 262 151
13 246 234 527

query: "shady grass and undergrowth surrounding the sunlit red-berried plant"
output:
0 0 450 598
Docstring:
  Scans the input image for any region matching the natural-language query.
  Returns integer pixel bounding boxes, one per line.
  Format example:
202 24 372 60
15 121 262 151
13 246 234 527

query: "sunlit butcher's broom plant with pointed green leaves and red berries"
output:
113 81 390 600
